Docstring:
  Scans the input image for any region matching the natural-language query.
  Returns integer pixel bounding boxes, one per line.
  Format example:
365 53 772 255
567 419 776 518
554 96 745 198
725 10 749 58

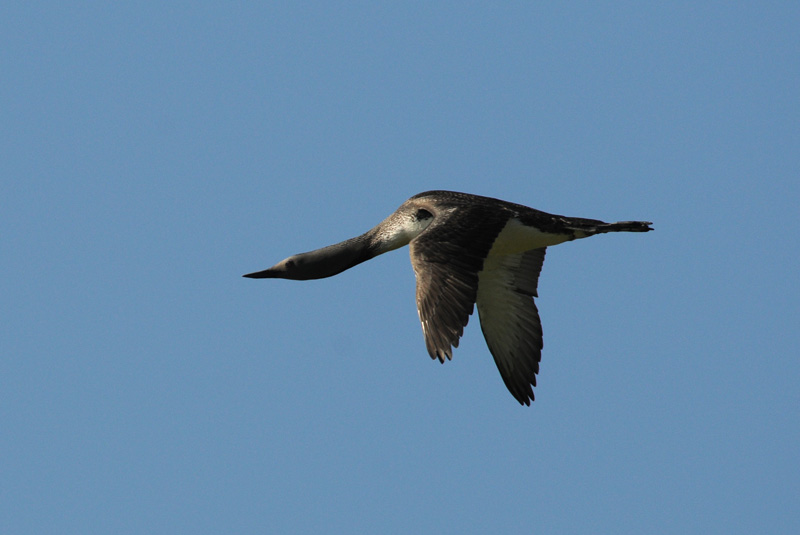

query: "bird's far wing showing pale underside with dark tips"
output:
477 247 545 405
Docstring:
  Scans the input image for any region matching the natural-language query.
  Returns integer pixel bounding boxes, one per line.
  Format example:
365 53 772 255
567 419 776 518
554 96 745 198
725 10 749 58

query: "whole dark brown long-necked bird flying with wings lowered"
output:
245 191 652 405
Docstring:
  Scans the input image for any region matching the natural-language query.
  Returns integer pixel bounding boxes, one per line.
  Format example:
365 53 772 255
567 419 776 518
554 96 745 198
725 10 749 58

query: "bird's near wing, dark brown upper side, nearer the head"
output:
411 205 509 362
